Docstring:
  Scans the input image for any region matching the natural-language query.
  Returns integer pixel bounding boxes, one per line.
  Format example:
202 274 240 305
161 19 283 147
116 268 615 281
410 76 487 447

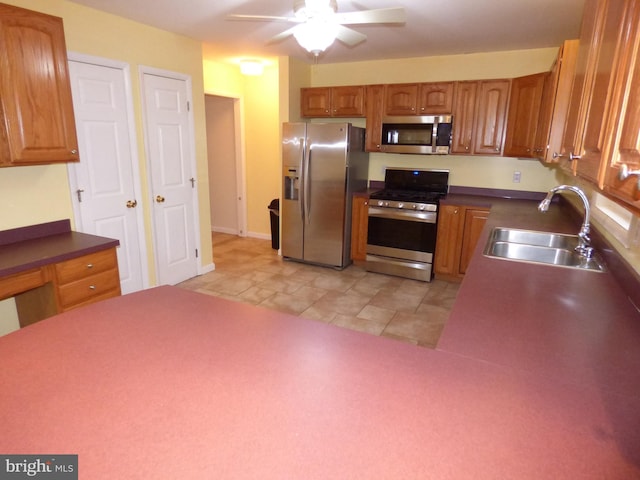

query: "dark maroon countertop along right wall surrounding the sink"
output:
438 198 640 398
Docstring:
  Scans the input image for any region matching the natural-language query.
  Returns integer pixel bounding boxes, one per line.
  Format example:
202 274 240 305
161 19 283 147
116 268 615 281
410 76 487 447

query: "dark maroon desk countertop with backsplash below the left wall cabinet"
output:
0 220 120 277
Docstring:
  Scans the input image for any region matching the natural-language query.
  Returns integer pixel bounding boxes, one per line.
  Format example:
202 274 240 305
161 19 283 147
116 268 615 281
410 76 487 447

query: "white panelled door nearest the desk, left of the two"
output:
69 55 148 293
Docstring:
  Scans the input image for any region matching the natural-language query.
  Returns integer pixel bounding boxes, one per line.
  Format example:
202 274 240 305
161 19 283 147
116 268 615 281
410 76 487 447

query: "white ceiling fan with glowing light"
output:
227 0 406 57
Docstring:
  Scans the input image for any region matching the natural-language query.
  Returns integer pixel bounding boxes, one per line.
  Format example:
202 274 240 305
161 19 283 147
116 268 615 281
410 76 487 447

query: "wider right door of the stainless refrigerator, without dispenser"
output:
303 123 349 267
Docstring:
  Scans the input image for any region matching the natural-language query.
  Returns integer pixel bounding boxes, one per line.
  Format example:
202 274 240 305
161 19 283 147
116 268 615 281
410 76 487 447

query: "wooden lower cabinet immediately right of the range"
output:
434 205 489 280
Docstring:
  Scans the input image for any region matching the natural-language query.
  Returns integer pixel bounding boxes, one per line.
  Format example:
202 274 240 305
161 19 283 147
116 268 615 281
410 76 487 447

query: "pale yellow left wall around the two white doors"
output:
0 0 213 284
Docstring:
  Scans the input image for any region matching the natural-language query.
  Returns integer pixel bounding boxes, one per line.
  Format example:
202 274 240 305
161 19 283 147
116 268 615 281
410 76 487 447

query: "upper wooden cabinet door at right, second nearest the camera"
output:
573 0 637 187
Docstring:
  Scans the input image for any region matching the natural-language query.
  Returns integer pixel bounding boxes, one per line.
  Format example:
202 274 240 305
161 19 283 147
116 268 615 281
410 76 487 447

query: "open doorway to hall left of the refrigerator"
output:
205 94 246 236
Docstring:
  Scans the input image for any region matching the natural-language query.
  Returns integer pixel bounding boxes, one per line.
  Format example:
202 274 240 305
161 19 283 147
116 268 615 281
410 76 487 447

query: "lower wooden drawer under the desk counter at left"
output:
58 268 120 310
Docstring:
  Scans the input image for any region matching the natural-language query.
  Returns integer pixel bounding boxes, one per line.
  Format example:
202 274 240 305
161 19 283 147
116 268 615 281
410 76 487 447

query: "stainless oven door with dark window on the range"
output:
367 206 437 263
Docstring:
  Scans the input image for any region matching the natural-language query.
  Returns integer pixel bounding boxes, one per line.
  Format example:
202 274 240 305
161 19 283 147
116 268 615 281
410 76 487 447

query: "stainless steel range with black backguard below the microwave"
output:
365 169 449 282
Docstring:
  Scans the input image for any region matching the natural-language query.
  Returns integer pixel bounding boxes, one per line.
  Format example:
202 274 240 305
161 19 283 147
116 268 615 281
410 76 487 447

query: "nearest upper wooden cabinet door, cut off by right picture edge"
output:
605 2 640 208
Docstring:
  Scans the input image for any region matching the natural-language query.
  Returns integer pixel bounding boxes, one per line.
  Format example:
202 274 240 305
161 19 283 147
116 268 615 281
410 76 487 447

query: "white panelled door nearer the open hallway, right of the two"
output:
142 73 198 285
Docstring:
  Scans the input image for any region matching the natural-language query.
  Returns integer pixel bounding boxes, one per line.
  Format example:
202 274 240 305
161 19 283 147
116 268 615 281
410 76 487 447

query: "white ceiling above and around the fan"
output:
67 0 585 63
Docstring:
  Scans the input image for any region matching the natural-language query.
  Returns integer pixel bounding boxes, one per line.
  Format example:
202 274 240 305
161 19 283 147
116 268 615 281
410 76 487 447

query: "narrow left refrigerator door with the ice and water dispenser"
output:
280 123 307 260
